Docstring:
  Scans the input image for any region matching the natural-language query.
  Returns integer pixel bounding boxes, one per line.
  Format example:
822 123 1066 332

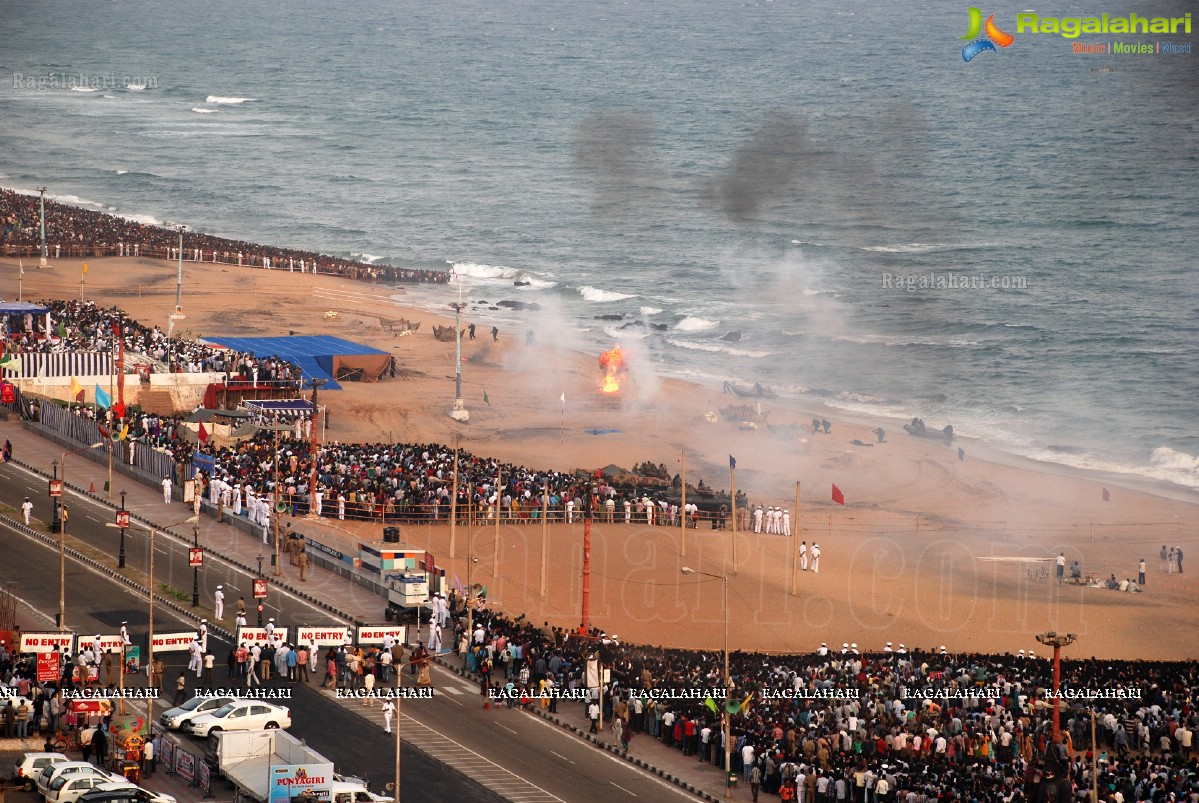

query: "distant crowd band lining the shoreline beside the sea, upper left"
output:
0 188 450 283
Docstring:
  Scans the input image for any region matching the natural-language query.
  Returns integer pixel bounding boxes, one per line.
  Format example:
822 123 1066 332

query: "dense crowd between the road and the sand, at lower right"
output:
452 606 1199 803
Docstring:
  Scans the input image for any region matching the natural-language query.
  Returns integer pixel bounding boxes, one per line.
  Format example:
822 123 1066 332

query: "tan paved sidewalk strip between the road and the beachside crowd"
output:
0 421 749 802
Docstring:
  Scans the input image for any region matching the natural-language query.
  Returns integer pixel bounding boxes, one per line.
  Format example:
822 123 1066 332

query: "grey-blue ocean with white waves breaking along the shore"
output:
0 0 1199 488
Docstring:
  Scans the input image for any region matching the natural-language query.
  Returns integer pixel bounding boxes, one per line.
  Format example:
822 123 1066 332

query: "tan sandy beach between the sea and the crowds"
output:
0 258 1199 659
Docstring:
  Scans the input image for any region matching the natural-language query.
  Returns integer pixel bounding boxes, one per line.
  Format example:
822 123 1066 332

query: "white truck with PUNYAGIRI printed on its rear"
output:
204 729 393 803
